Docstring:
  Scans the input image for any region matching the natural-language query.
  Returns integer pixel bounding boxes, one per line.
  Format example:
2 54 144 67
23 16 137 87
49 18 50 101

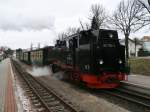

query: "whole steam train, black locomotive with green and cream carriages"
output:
16 29 129 89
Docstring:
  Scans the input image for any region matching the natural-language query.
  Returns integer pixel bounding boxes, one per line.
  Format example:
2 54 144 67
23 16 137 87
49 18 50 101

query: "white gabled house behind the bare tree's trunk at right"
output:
120 38 142 57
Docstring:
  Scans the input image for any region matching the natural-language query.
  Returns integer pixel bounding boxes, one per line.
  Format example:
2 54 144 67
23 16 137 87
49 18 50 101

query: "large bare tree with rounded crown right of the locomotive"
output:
111 0 146 59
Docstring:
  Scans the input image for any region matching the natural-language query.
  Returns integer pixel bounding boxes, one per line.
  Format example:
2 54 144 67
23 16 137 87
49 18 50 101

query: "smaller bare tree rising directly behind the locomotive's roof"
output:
90 4 108 29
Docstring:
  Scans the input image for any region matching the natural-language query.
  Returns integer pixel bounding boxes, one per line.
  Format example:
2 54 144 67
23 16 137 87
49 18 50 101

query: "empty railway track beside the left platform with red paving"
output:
12 60 81 112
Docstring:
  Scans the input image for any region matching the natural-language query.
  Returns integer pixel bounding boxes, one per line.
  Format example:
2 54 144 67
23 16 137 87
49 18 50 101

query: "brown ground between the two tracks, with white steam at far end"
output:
20 64 129 112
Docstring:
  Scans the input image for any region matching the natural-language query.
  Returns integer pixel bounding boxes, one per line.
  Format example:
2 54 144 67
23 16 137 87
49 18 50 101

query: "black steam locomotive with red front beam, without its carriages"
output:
52 29 128 88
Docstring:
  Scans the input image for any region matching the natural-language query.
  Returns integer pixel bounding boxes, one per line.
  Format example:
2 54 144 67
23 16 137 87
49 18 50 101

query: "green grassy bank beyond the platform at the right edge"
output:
129 58 150 76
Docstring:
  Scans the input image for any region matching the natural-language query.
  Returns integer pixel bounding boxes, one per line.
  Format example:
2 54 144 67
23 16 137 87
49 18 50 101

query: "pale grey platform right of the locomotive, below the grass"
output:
127 74 150 88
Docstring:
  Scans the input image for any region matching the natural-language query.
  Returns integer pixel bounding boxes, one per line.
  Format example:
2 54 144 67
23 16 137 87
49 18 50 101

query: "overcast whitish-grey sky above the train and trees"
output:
0 0 150 49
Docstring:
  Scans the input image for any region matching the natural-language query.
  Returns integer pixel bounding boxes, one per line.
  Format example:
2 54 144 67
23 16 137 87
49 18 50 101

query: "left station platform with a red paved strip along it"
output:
0 59 17 112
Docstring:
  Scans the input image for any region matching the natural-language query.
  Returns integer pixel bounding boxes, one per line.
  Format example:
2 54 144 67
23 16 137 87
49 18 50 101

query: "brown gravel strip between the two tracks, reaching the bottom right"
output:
17 60 145 112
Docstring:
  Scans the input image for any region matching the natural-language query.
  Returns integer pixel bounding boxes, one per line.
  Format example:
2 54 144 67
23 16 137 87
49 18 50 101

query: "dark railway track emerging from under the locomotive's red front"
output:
104 88 150 109
